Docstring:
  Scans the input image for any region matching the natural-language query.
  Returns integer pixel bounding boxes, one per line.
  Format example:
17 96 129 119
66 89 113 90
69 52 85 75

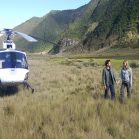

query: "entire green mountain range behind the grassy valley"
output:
7 0 139 54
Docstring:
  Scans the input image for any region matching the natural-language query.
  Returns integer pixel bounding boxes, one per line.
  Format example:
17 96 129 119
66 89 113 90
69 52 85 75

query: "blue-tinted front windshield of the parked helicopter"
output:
0 52 28 69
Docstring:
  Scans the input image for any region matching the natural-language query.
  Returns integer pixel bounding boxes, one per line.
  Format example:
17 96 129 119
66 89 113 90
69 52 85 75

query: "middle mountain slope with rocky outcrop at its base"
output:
50 0 100 54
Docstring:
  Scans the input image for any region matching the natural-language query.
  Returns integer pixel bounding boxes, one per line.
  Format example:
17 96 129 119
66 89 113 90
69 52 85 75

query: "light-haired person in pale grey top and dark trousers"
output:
120 60 132 101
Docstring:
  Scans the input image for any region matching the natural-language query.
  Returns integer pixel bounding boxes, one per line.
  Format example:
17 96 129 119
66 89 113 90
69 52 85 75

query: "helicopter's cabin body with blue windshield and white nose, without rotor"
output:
0 49 29 86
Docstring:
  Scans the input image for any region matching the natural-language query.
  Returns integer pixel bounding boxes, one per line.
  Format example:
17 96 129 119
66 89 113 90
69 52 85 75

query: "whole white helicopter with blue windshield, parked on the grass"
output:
0 29 37 93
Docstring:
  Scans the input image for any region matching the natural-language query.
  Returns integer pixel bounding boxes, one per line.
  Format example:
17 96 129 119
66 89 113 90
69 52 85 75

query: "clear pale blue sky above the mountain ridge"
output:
0 0 90 30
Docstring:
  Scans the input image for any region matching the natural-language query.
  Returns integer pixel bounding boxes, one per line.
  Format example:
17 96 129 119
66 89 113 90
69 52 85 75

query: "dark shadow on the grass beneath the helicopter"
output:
0 86 19 97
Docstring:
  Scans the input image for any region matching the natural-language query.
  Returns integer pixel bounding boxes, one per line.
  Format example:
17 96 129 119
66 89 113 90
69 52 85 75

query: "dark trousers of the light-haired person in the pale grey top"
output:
120 82 131 99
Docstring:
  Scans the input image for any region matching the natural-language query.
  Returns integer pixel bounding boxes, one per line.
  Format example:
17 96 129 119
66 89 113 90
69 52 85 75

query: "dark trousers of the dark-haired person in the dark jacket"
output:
104 85 115 99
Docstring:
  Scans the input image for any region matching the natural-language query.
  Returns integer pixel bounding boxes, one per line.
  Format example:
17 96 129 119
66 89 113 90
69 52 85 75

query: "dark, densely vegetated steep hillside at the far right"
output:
83 0 139 50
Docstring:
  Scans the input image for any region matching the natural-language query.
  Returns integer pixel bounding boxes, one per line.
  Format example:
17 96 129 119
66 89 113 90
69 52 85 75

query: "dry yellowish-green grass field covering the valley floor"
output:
0 55 139 139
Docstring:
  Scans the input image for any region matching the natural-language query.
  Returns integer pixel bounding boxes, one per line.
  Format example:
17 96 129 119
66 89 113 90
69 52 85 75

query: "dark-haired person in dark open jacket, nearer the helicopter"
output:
102 60 116 100
